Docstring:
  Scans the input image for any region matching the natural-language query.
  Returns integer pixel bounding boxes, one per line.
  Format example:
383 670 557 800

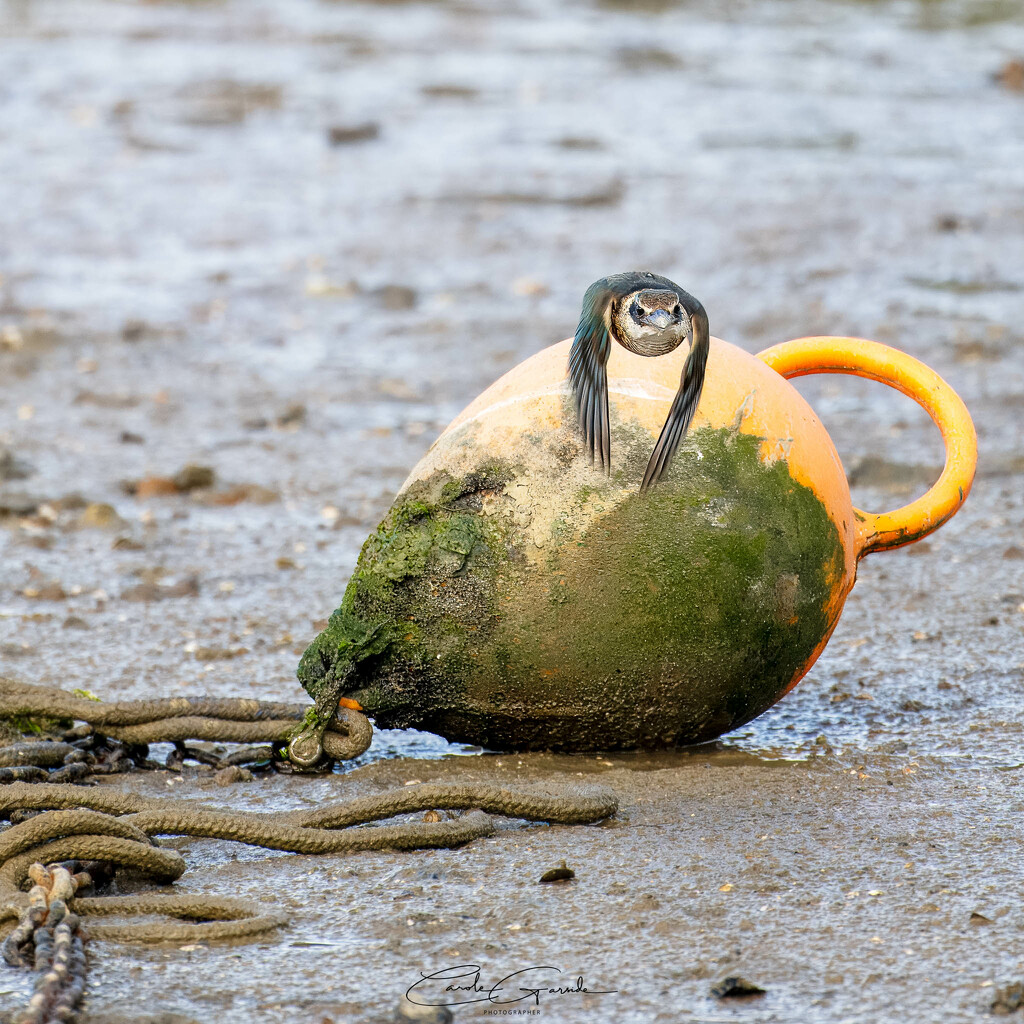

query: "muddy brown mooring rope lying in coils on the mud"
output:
0 680 617 1024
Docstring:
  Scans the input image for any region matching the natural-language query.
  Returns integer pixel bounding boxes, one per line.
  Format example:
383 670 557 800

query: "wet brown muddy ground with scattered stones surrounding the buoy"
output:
0 0 1024 1024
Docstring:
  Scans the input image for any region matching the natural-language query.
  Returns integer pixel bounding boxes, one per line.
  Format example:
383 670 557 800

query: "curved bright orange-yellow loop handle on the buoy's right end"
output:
758 338 978 558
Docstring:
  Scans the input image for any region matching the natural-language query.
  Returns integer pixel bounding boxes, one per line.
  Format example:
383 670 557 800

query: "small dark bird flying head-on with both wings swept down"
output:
568 270 710 492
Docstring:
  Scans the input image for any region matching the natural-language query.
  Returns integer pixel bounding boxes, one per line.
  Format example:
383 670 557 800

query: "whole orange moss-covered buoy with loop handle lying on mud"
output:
299 338 977 751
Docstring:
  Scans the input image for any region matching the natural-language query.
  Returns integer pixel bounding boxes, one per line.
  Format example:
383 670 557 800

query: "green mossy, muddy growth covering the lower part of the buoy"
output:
299 427 844 750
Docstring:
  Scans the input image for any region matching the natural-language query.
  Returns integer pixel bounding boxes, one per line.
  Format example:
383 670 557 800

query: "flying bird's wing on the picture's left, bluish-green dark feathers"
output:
569 280 612 473
